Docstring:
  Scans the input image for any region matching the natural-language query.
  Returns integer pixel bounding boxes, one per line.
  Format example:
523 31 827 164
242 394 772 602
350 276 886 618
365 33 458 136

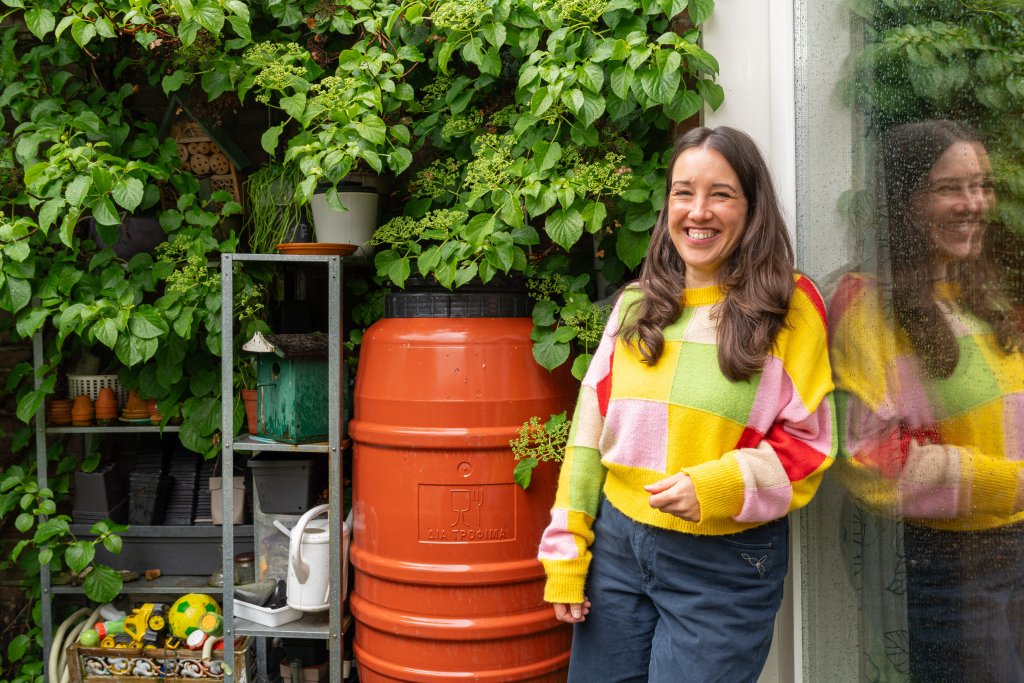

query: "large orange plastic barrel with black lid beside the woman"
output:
349 286 577 683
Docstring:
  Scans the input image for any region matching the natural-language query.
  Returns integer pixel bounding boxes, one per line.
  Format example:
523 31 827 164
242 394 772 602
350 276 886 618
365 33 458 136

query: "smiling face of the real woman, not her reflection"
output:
668 147 746 289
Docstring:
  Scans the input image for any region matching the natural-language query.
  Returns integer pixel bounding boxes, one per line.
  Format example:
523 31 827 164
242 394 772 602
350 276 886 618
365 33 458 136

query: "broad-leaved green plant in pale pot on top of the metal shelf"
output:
239 37 422 246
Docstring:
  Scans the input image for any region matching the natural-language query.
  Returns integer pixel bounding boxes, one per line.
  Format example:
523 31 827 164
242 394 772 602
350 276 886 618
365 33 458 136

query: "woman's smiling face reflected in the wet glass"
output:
910 141 994 273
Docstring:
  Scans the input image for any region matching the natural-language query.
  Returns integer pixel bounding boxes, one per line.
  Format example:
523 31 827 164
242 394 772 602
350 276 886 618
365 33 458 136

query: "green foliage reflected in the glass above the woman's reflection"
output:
845 0 1024 236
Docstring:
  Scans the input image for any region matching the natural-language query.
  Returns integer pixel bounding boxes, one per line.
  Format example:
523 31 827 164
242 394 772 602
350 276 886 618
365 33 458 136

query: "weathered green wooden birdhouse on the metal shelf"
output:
243 333 330 443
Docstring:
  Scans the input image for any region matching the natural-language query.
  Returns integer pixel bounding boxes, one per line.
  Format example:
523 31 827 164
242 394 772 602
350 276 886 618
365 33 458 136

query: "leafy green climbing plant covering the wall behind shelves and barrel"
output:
0 0 722 680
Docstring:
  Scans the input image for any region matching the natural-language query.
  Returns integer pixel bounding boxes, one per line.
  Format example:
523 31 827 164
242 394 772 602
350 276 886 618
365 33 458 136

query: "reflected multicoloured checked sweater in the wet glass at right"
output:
830 274 1024 530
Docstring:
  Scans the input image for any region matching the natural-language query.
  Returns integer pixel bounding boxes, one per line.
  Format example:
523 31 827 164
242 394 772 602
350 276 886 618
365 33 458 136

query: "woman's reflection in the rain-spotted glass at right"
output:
830 121 1024 683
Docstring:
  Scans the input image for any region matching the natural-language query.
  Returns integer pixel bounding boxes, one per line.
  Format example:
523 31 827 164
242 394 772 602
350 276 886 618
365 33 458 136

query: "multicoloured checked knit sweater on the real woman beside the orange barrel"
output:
538 275 836 602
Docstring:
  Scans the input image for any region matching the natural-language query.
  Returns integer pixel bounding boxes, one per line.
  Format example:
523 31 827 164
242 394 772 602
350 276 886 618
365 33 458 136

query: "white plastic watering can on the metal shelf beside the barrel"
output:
273 505 331 612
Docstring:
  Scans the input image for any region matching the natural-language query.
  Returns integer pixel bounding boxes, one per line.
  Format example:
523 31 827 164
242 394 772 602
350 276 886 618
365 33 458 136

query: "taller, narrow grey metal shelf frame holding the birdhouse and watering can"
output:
220 254 345 683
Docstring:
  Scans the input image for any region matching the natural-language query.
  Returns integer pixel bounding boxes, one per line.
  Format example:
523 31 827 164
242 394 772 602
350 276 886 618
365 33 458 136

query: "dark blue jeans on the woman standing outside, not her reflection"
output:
569 501 790 683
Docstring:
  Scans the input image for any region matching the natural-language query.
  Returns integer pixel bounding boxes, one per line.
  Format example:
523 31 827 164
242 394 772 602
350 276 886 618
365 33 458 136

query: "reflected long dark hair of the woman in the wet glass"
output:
883 120 1022 377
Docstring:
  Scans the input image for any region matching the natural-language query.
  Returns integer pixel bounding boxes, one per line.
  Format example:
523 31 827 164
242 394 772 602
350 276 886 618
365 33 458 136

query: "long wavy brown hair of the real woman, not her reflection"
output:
621 126 794 381
